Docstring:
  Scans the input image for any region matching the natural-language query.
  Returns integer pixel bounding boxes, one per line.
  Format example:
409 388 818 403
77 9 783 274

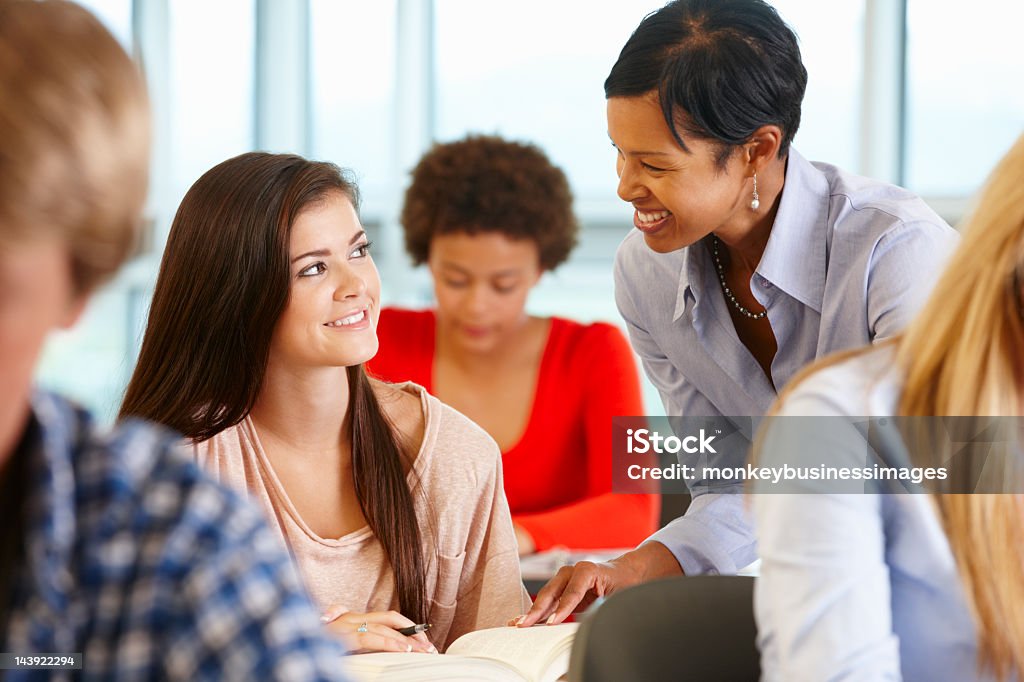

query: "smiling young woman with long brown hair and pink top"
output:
121 153 528 650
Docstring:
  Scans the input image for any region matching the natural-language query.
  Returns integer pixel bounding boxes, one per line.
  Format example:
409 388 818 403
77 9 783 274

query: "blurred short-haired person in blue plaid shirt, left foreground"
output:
0 0 343 680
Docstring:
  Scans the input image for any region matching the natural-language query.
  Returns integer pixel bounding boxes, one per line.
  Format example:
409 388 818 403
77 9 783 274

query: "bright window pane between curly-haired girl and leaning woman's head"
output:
435 0 651 212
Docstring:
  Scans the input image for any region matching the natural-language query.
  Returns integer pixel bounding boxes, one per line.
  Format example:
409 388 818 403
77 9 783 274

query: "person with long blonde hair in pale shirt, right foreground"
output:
754 137 1024 680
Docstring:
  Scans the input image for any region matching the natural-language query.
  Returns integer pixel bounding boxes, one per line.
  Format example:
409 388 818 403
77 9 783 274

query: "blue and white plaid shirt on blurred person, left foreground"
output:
0 393 343 681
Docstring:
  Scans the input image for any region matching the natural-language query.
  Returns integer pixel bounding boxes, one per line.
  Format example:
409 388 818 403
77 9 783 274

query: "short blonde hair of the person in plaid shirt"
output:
0 0 150 294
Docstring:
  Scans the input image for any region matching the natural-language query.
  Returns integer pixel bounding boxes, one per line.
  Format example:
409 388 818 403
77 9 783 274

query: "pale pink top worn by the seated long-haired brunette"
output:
194 383 529 650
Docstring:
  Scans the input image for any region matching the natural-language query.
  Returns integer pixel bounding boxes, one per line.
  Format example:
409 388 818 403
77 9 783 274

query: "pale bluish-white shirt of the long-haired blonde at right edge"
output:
753 347 981 682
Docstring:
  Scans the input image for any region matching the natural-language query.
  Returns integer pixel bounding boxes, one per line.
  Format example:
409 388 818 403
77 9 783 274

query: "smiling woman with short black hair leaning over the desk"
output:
522 0 955 626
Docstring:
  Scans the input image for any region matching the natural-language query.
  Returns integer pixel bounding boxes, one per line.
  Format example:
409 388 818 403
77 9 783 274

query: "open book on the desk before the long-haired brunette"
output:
345 623 579 682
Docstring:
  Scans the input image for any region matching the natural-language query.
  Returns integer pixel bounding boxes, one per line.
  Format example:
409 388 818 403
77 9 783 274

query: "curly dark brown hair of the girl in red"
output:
401 135 579 270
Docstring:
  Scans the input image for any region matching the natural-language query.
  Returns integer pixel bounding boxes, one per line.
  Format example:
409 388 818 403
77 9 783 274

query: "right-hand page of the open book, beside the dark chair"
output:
447 623 580 682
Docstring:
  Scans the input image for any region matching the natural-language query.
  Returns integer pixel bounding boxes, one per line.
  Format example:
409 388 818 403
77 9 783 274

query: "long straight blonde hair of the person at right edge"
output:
755 135 1024 679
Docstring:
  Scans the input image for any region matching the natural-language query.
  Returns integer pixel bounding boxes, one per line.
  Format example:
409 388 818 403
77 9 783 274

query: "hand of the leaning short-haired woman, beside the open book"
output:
509 542 683 628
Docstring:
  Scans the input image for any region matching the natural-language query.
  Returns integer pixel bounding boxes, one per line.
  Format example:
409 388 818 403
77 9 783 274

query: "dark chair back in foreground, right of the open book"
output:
569 576 761 682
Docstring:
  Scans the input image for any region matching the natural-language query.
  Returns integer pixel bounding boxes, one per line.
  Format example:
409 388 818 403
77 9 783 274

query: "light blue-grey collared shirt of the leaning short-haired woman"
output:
614 148 956 574
